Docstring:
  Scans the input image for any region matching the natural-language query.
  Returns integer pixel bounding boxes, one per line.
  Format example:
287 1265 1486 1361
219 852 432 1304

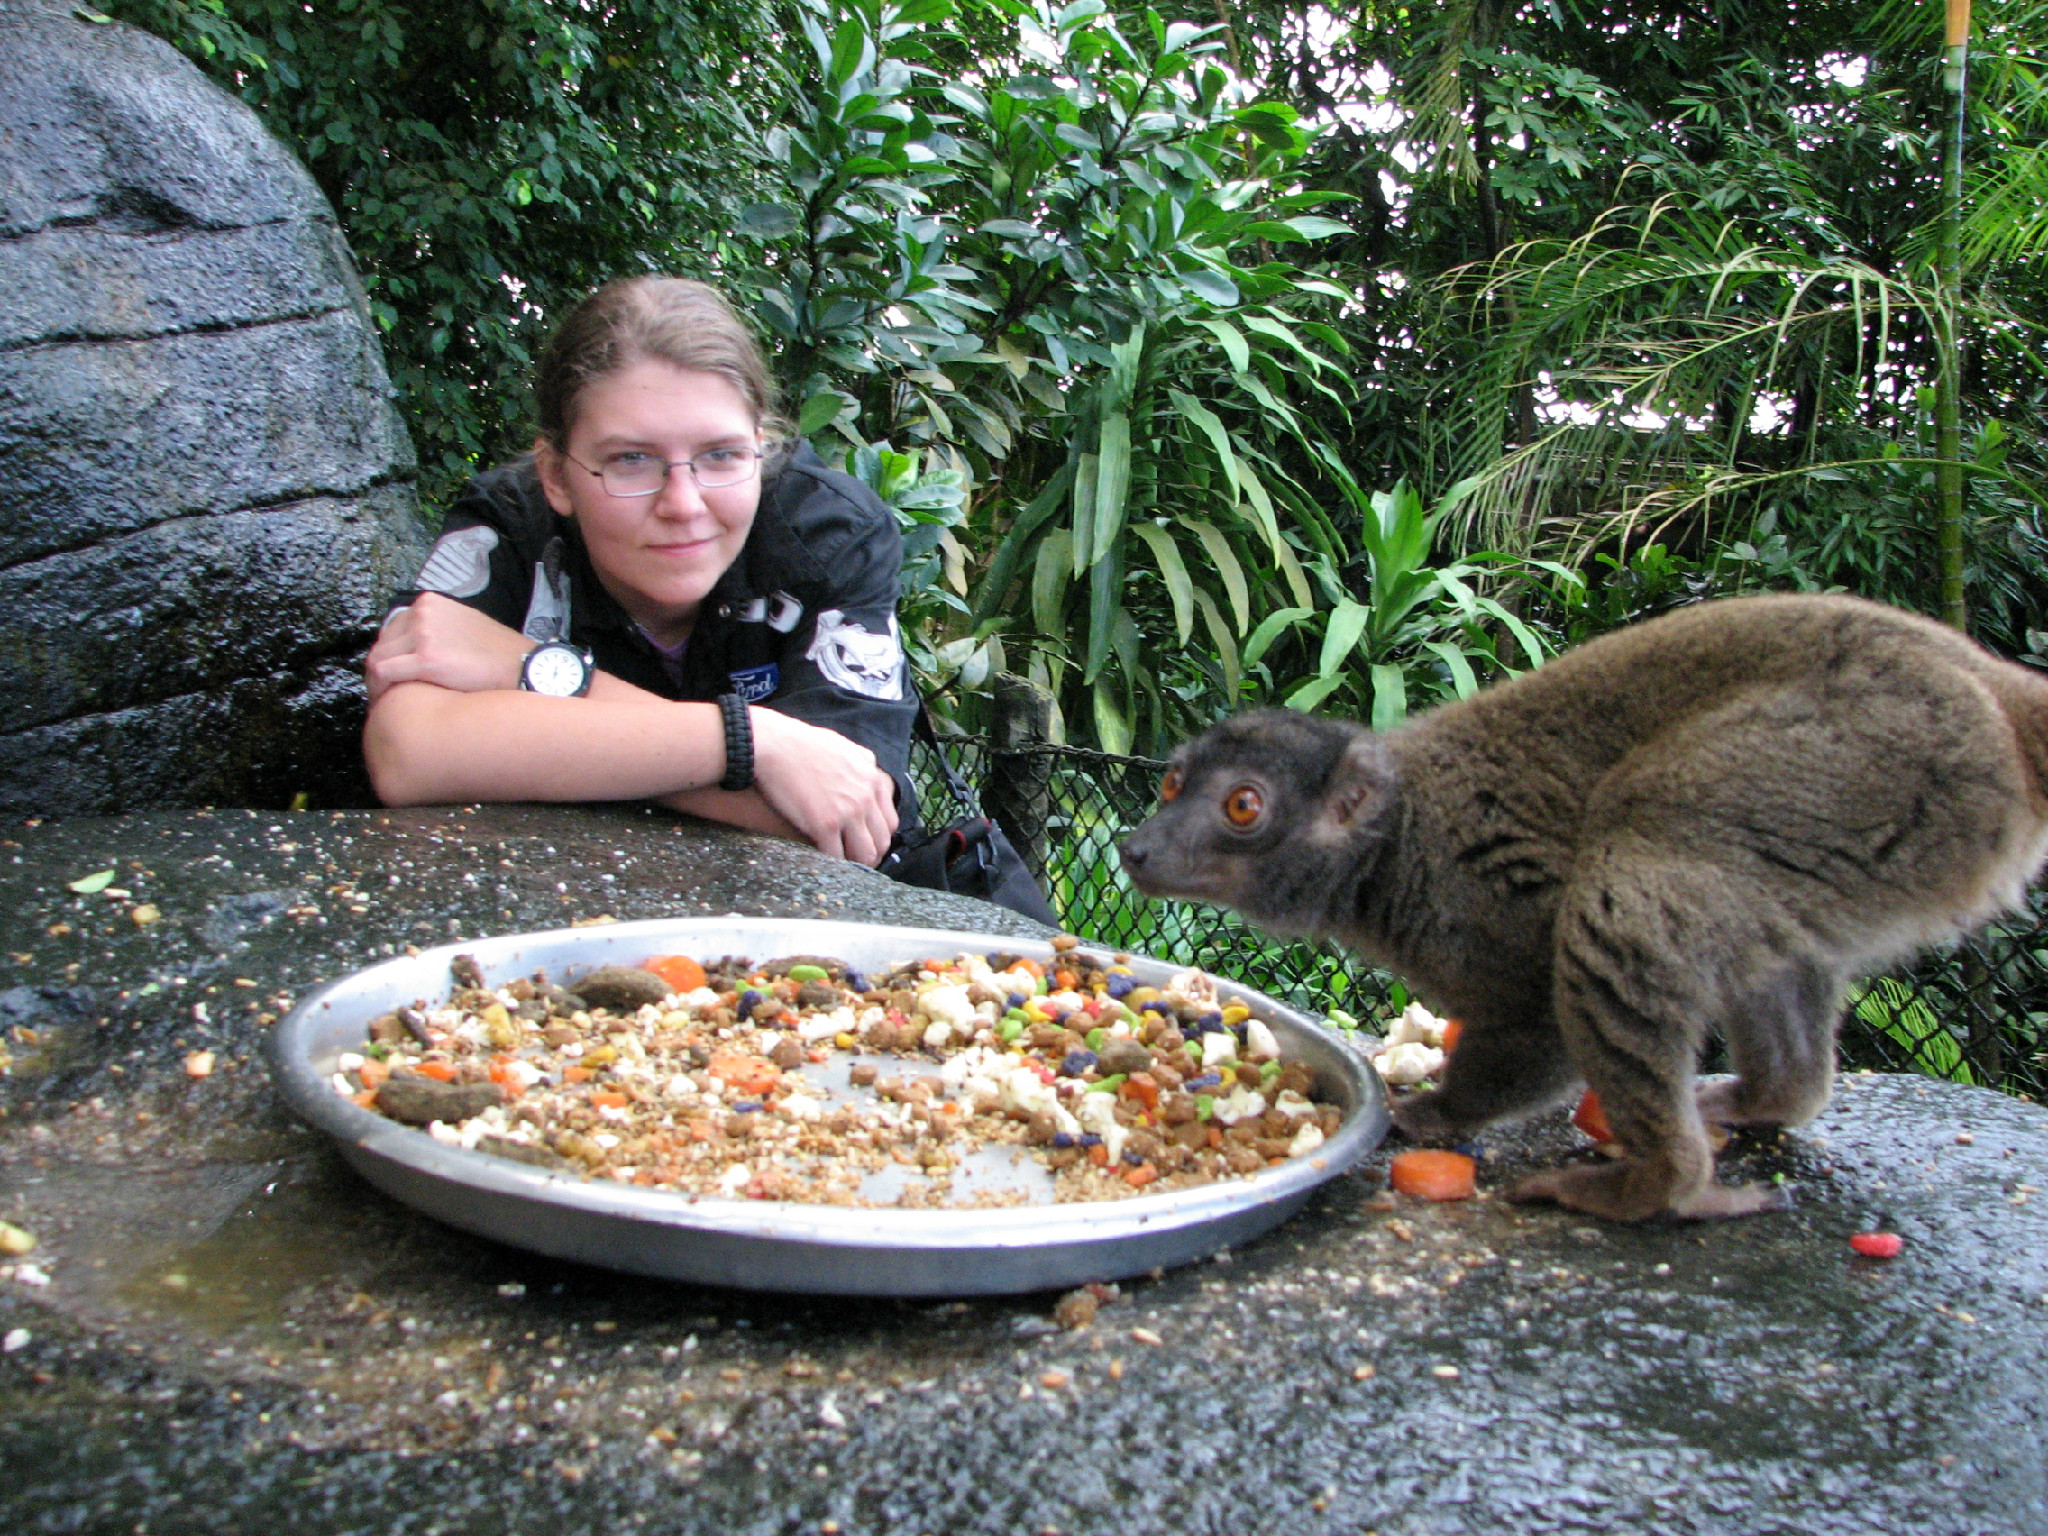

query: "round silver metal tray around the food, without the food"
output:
270 918 1389 1296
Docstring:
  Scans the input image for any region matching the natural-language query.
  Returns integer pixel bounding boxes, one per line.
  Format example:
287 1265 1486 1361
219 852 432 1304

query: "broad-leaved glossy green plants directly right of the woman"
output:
739 0 1540 752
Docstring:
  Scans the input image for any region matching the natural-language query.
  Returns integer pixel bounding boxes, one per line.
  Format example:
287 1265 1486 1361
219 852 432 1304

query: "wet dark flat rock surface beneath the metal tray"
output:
0 809 2048 1536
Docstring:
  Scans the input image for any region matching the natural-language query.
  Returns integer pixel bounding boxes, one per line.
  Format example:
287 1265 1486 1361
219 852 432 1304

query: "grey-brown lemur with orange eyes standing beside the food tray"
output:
1124 596 2048 1219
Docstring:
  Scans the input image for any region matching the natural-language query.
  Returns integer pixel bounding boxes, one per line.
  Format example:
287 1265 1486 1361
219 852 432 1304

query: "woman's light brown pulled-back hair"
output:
532 276 788 451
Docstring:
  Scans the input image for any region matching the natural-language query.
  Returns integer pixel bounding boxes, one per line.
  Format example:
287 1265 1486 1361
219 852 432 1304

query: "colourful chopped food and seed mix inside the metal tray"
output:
334 936 1339 1208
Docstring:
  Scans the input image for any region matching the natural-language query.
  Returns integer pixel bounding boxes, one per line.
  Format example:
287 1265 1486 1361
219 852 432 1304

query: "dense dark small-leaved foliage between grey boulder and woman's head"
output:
106 0 766 498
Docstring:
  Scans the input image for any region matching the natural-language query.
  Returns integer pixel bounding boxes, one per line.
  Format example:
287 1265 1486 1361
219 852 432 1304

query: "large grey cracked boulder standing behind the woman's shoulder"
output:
0 0 426 815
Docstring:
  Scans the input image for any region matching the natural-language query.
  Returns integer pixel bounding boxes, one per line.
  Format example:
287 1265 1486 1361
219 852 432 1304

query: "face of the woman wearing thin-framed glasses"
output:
535 358 762 645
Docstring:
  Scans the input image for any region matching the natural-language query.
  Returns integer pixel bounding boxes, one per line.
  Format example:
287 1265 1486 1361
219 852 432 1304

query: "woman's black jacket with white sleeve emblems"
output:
399 446 918 825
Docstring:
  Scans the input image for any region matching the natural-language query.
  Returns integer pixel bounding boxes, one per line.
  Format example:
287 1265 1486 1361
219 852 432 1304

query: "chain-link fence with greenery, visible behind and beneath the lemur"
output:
911 737 2048 1100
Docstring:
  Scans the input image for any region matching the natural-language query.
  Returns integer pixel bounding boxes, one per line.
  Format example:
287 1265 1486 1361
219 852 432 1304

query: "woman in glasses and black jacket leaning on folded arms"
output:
362 276 918 864
